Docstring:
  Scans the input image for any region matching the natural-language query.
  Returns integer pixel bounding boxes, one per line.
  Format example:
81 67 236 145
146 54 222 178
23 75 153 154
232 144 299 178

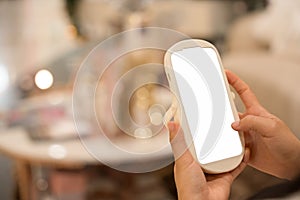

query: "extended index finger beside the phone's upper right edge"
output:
225 70 259 109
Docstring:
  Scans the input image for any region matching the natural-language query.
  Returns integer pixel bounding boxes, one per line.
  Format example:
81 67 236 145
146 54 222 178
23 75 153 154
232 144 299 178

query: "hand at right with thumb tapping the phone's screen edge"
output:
226 71 300 179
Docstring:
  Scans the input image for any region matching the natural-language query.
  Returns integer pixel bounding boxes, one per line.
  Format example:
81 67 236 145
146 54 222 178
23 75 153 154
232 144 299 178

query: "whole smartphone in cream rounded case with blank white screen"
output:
164 39 244 173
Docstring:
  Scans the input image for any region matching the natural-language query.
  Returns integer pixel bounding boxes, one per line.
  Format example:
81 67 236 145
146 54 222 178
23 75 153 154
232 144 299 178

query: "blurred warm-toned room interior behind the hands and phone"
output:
0 0 300 200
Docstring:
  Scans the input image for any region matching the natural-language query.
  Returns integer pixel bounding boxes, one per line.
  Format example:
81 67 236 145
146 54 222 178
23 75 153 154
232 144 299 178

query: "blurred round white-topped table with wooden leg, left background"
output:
0 127 172 200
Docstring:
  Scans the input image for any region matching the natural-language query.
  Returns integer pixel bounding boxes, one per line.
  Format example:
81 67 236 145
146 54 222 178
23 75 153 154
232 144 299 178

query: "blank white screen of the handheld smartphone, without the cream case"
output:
171 47 243 164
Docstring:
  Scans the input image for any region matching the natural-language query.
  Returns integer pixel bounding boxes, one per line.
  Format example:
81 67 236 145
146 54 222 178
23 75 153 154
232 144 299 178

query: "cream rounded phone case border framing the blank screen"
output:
164 39 245 174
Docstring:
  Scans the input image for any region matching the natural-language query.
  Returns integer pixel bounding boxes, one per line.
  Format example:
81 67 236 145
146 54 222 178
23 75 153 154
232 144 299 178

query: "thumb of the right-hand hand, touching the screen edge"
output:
231 115 275 136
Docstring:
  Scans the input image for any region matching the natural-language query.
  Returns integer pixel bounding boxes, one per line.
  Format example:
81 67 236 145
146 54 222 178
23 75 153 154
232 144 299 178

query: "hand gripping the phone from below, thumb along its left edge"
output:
168 122 249 200
